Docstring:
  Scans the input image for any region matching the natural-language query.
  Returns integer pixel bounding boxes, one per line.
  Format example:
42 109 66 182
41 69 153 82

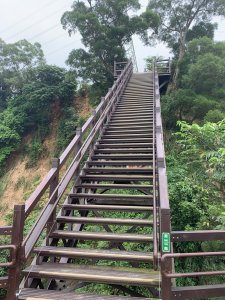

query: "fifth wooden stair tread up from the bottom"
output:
57 216 153 226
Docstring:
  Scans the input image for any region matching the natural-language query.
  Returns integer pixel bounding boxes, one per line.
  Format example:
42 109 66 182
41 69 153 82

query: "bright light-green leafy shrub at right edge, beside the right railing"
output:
177 120 225 191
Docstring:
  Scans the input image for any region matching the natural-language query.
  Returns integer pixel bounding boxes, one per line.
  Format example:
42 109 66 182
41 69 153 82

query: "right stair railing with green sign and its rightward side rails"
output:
155 62 225 300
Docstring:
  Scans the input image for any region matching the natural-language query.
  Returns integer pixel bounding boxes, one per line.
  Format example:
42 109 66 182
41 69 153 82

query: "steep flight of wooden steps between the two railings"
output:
18 73 161 300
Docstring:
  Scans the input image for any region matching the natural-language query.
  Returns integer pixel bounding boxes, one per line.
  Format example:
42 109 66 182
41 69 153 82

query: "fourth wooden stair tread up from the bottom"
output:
50 230 153 243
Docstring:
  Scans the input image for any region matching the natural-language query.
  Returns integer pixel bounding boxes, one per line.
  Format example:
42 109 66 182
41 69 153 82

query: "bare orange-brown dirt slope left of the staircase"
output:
0 98 92 225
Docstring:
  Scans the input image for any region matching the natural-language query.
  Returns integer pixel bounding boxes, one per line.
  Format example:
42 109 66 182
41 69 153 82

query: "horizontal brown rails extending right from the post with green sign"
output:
161 230 225 299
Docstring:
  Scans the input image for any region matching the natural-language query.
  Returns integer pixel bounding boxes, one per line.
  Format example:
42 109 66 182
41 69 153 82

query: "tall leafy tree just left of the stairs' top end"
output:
61 0 158 103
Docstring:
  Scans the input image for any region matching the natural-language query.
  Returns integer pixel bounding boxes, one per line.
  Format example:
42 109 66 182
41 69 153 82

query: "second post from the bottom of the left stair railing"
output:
46 158 59 245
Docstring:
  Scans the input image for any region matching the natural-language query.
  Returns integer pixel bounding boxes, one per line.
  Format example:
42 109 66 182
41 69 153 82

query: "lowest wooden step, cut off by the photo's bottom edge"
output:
18 289 158 300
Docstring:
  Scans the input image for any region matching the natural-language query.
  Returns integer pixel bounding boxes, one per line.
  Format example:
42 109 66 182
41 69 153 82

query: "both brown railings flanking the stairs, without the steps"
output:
0 57 225 300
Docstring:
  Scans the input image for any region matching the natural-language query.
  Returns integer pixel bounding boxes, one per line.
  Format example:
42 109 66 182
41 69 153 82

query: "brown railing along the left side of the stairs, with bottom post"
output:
0 61 133 300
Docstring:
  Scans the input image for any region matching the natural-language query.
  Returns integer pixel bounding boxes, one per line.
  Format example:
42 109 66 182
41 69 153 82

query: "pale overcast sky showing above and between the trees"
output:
0 0 225 70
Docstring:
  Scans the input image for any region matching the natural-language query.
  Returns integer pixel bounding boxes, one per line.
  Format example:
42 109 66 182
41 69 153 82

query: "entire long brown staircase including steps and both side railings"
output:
0 62 225 300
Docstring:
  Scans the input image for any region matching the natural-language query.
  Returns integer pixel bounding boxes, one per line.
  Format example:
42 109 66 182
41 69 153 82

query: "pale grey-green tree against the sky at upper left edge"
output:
0 39 45 110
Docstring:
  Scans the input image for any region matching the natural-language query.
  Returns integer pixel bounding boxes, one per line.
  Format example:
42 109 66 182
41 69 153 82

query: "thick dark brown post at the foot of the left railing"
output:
6 204 25 300
